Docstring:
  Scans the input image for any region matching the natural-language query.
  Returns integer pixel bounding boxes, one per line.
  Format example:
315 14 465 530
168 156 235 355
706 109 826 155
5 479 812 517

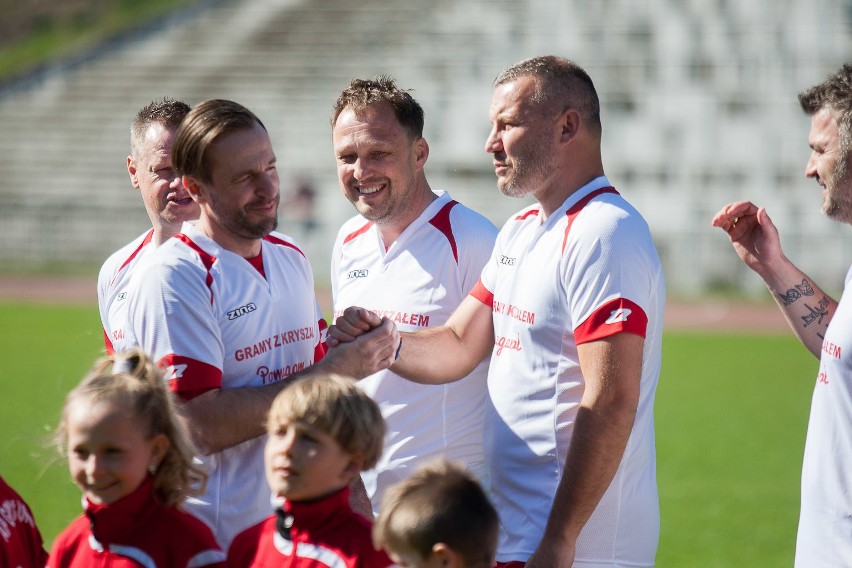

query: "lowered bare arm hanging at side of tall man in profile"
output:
526 333 644 568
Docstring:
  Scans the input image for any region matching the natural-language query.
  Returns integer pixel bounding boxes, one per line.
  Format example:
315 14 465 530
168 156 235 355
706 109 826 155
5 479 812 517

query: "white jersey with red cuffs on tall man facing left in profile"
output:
472 177 665 566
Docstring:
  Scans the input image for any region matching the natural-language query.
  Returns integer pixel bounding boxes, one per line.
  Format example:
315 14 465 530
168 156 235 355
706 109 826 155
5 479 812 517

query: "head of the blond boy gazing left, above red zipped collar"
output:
265 375 385 501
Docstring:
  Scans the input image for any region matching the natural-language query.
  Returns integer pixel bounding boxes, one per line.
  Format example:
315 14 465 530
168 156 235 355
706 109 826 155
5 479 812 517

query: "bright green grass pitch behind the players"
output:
0 303 817 568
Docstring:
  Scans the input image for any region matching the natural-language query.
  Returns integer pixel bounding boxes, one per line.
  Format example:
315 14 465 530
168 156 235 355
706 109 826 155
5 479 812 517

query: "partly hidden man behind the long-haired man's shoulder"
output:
98 99 198 353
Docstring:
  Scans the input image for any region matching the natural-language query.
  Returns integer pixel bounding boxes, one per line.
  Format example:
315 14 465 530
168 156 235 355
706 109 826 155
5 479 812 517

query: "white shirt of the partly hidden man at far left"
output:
98 229 157 354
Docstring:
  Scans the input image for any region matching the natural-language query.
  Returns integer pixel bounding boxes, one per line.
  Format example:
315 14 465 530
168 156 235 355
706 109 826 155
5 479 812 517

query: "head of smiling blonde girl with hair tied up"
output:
55 349 207 505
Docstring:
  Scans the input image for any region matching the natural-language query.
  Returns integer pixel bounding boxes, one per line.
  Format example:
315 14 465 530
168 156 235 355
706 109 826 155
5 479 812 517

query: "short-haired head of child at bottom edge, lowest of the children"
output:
373 459 499 568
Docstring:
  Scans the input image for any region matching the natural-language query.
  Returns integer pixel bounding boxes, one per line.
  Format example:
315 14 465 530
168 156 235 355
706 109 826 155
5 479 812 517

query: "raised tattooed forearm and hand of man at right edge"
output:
712 201 837 358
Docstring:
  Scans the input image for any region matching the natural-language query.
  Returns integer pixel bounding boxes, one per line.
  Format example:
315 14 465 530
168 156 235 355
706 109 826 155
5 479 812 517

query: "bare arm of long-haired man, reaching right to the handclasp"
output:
182 320 398 454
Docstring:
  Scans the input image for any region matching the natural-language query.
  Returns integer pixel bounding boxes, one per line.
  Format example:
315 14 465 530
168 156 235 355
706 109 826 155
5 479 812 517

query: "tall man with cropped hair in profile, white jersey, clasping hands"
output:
332 56 665 568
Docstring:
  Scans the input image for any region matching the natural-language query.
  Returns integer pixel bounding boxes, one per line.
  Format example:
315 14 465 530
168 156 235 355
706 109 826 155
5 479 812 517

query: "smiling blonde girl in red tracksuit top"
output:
47 350 225 568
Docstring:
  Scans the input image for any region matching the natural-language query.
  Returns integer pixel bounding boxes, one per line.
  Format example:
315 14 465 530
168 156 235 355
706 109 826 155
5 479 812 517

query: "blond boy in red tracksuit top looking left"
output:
228 376 393 568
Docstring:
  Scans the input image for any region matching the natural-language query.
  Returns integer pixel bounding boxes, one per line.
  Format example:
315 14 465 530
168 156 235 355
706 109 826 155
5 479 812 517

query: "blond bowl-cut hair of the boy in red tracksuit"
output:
267 375 385 470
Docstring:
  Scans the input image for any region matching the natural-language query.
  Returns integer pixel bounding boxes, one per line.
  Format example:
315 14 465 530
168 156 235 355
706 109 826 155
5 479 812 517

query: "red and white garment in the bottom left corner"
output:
0 477 47 568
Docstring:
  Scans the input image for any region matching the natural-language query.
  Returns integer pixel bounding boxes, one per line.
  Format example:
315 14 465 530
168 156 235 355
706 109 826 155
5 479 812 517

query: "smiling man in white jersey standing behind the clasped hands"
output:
331 76 497 513
